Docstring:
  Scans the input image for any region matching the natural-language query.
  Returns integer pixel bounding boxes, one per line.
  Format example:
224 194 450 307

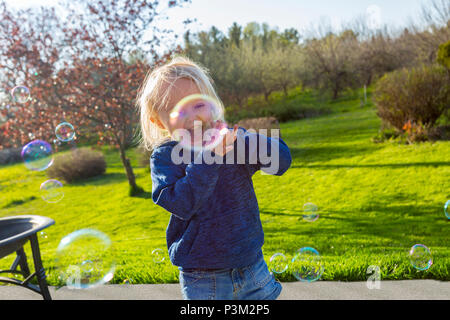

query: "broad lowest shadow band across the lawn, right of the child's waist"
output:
261 197 447 249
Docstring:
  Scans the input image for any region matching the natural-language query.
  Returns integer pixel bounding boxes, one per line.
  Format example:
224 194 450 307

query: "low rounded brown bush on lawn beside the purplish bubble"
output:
47 148 106 183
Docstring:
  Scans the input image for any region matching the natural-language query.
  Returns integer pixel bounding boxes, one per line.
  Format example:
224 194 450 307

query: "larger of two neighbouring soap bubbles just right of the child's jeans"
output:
291 247 324 282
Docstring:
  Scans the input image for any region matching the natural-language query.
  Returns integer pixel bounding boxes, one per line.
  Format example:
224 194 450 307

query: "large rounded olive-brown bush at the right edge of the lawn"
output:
373 65 450 135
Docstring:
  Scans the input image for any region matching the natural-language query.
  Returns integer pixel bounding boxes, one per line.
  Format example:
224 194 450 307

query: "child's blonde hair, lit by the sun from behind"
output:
136 56 224 151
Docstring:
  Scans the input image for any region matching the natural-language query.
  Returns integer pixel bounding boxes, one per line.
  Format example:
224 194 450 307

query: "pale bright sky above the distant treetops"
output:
6 0 430 50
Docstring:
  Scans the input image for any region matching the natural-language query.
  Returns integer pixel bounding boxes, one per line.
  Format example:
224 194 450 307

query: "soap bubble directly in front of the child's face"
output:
169 94 228 151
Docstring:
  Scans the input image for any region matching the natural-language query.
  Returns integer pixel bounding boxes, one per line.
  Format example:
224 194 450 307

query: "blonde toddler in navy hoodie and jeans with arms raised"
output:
137 57 291 300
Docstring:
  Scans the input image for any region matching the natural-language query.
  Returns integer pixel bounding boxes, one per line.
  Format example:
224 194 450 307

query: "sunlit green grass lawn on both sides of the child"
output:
0 90 450 285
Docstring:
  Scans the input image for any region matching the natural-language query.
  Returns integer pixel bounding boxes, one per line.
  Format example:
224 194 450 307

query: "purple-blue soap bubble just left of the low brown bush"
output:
21 140 53 171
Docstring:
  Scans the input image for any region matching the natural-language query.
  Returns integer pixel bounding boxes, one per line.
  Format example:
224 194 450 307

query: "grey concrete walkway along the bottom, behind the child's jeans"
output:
0 280 450 300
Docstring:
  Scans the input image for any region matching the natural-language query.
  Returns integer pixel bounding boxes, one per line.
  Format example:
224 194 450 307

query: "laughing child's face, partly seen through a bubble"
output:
158 78 214 136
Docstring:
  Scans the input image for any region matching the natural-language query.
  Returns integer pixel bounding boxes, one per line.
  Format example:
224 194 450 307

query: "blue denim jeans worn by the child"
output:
180 258 282 300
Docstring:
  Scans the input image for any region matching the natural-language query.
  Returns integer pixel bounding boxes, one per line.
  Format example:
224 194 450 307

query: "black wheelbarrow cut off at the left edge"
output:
0 215 55 300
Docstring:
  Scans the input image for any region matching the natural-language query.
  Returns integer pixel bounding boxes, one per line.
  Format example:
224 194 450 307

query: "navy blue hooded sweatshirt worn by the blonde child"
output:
150 128 292 270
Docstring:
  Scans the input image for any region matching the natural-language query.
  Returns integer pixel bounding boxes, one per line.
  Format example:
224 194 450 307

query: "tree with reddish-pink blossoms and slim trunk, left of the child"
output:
0 0 189 193
